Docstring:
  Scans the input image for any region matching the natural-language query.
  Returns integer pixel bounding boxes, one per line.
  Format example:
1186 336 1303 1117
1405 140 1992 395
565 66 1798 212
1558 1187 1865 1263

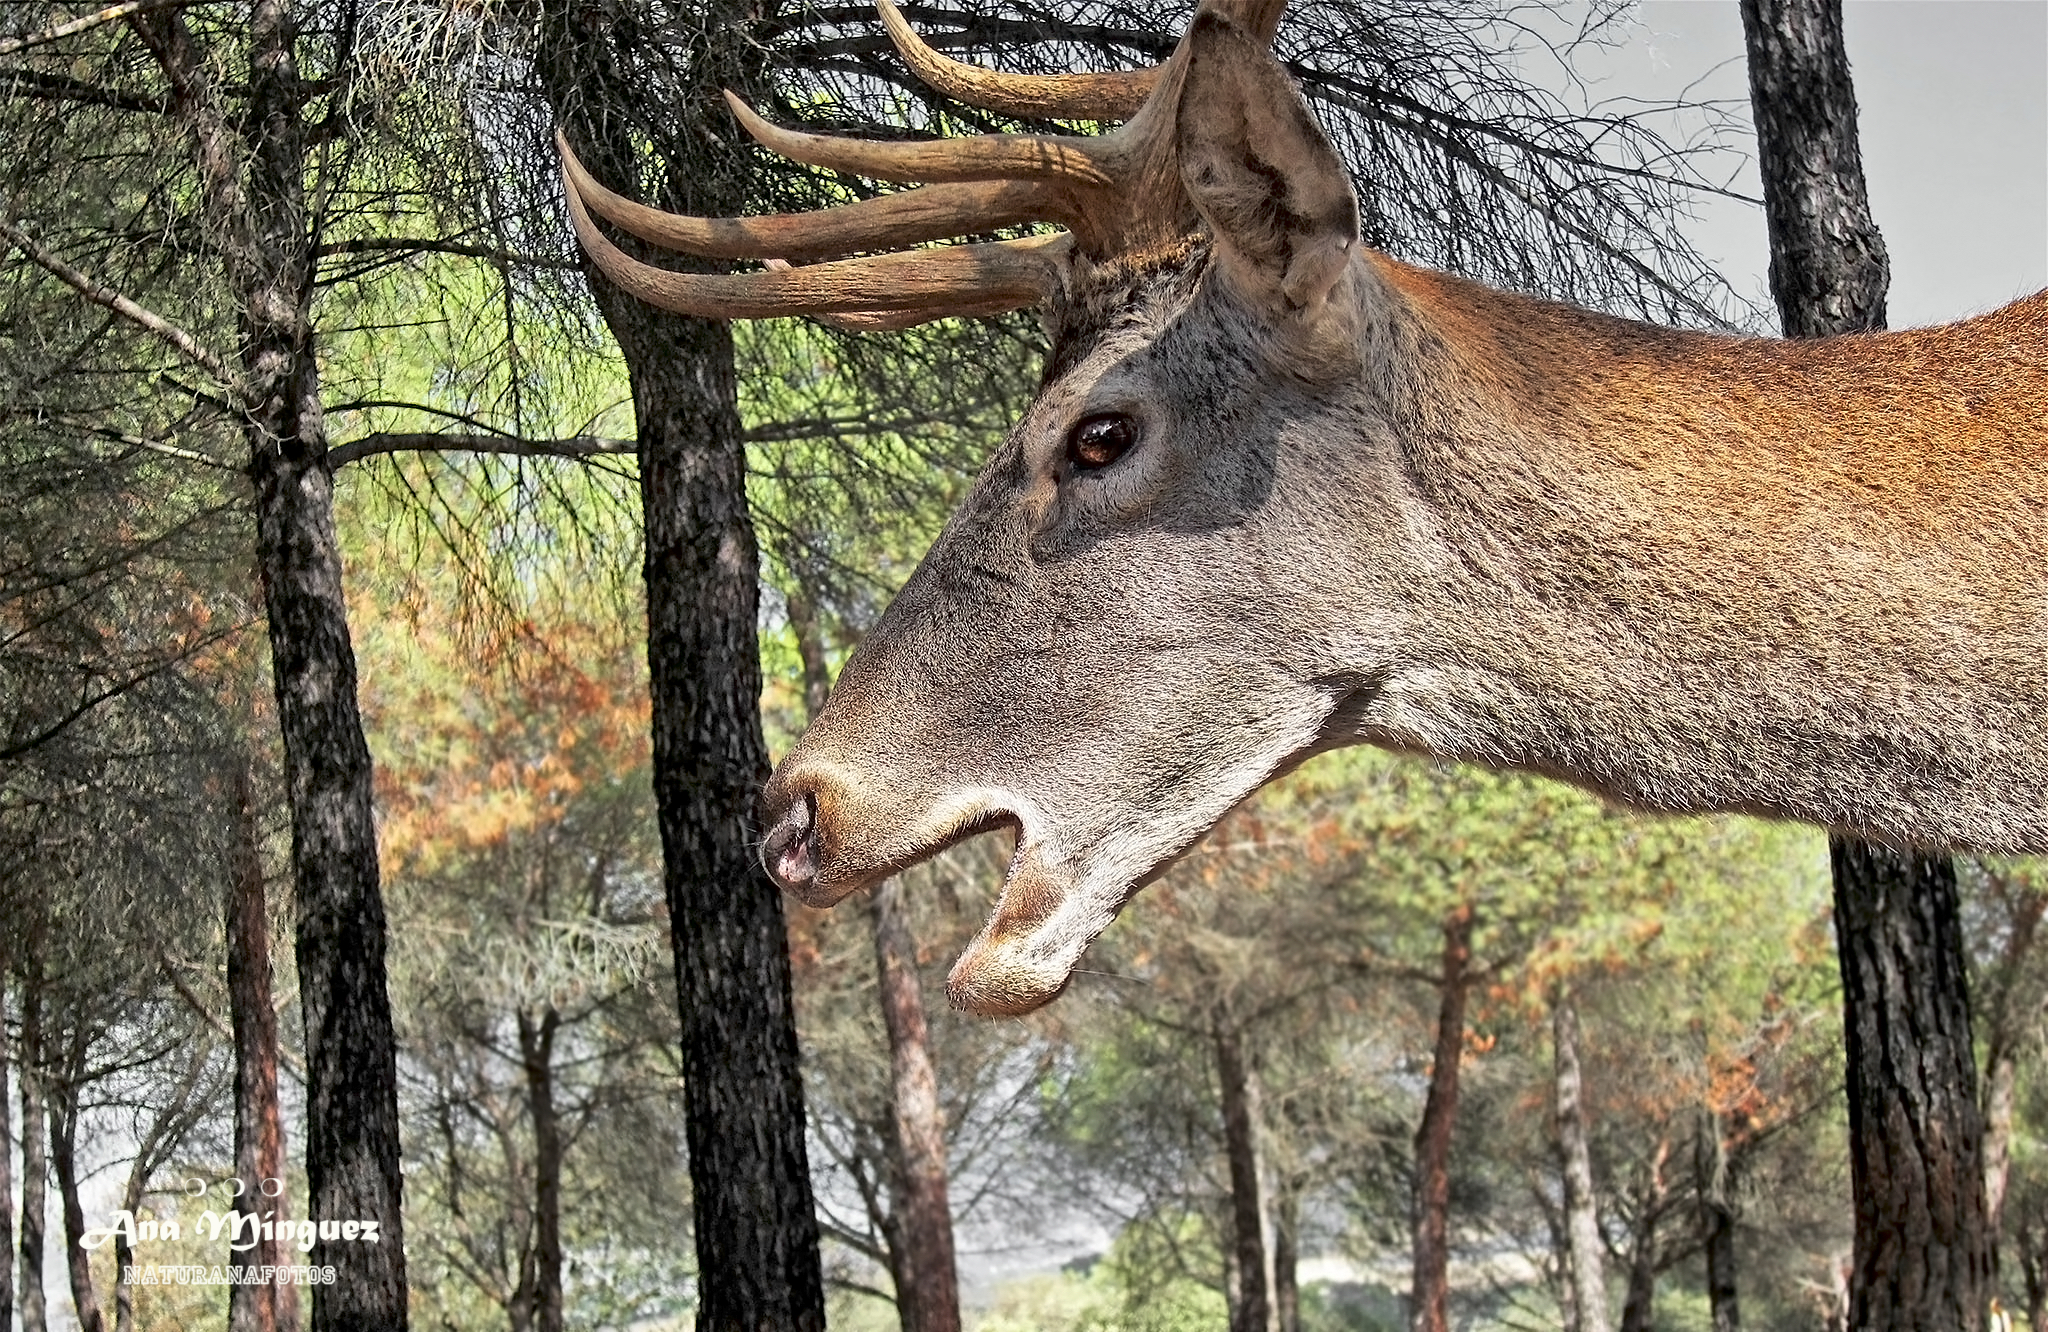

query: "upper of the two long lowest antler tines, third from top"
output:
555 129 1071 262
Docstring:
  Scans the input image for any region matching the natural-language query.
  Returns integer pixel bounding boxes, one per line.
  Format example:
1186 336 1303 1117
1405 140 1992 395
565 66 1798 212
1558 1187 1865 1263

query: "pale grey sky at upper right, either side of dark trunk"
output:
1581 0 2048 328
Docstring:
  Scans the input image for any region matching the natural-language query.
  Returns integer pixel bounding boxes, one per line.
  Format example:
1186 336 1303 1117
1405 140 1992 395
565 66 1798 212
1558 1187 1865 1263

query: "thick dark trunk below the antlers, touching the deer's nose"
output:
622 279 825 1332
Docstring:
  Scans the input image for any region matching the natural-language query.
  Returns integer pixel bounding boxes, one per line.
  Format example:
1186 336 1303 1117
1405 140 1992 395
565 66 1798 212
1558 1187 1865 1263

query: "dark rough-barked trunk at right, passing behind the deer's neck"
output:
1743 0 1991 1332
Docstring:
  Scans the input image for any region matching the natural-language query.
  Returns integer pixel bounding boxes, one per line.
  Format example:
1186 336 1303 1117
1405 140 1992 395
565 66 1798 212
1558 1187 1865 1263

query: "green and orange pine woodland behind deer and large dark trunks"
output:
0 2 2048 1332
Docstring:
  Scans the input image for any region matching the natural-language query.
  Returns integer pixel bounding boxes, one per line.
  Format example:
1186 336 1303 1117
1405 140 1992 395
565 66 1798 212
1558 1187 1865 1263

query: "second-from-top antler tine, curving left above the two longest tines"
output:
725 92 1114 186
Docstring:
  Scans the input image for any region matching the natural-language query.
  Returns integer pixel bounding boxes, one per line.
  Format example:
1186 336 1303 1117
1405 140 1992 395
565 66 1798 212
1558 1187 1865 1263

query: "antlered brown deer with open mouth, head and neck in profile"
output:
559 0 2048 1016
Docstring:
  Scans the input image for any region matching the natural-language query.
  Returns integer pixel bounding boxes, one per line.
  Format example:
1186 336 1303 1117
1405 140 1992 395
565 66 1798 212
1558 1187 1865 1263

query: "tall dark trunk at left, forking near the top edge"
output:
131 0 408 1332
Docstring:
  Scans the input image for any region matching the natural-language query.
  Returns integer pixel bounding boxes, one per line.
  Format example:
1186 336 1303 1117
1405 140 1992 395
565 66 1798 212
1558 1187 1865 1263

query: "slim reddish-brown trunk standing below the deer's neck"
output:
1409 906 1473 1332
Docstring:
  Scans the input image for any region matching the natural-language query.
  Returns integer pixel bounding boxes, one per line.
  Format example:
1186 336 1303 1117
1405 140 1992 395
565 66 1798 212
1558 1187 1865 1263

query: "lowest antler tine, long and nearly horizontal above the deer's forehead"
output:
565 160 1071 320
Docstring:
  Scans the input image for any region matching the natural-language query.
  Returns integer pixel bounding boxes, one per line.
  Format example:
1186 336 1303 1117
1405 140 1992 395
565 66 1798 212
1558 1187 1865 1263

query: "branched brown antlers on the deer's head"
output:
555 0 1286 328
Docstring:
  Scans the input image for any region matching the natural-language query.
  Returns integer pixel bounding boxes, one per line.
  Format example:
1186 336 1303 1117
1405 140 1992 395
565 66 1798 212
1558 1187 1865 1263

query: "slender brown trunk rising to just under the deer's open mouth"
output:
872 879 961 1332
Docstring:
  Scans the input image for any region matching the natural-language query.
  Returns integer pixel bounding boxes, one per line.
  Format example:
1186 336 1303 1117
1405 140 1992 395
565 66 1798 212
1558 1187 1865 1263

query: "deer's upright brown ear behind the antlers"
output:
1176 10 1358 314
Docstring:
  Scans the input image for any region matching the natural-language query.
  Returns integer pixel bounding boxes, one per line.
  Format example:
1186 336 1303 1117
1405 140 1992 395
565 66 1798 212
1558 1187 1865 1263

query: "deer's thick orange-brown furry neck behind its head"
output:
1335 258 2048 848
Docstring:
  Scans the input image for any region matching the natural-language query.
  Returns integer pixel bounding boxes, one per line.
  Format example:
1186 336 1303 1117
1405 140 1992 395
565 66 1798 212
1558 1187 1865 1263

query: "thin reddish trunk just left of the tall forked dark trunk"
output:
230 758 299 1332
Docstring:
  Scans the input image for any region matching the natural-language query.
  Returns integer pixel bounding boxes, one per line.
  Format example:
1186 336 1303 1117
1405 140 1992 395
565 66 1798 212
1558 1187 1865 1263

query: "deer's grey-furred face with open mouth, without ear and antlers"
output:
770 246 1391 1010
